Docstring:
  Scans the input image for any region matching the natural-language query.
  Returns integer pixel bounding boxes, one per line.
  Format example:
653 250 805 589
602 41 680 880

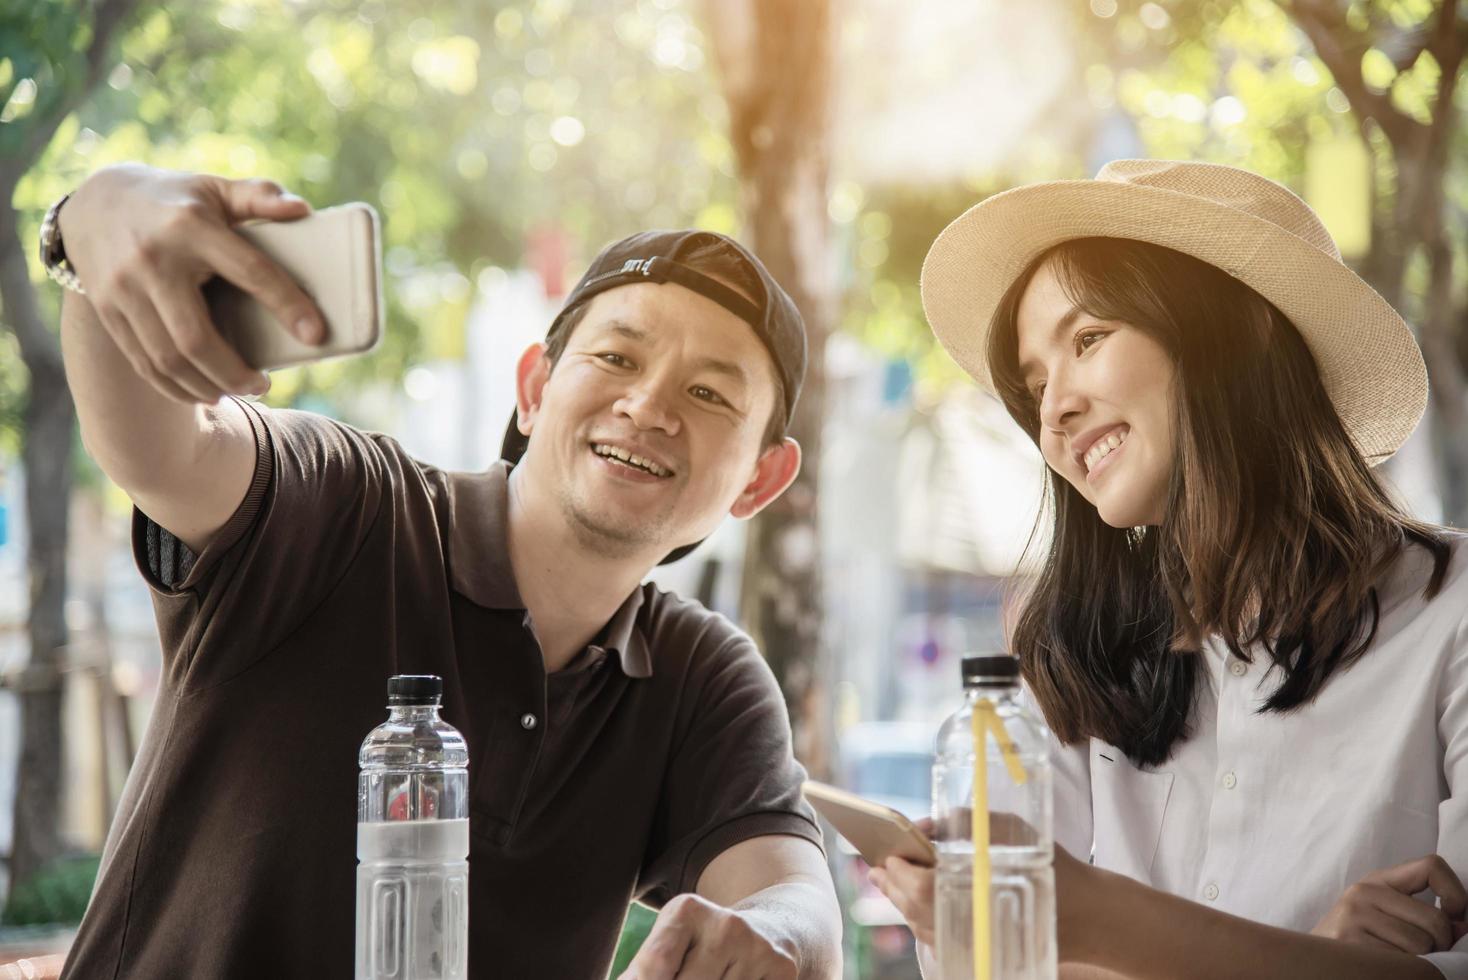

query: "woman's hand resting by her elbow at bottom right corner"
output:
1311 854 1468 955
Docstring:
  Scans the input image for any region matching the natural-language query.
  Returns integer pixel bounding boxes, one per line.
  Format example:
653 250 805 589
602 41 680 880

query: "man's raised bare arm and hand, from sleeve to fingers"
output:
60 164 319 553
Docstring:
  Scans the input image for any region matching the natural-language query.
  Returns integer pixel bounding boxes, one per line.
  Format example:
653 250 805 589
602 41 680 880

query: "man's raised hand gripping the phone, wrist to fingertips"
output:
59 164 326 405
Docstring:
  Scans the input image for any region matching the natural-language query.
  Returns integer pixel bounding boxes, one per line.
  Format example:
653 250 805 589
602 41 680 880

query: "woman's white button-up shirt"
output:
1053 535 1468 980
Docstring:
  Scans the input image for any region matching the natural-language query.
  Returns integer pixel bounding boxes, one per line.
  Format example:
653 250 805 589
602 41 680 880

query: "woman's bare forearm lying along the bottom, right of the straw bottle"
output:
1080 871 1442 980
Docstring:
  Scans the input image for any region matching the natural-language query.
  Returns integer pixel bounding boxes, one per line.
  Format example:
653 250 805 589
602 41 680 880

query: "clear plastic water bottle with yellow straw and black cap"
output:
932 656 1057 980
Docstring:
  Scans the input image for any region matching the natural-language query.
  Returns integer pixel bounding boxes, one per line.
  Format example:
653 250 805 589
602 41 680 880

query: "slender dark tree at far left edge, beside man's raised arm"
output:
0 0 137 891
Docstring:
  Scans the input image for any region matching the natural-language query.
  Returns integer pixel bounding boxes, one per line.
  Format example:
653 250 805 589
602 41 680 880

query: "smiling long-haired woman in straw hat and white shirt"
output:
873 160 1468 979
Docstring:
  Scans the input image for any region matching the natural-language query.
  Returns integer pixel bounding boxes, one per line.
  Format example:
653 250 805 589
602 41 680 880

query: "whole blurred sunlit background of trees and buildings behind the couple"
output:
0 0 1468 977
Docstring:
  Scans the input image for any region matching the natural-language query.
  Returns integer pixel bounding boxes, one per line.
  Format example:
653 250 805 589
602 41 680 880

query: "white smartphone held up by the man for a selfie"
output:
204 202 383 371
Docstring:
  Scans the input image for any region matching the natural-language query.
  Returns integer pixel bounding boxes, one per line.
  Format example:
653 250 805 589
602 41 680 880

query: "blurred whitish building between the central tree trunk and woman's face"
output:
821 336 1042 739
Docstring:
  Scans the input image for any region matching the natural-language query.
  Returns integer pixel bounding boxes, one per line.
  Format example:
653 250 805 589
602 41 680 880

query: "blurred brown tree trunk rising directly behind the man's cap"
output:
706 0 835 772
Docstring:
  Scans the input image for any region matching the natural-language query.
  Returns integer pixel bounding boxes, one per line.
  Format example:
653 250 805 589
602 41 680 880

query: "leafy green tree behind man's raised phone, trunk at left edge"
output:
0 0 737 903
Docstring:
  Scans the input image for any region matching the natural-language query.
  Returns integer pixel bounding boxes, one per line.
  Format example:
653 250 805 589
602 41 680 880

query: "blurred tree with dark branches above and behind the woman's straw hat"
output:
1073 0 1468 525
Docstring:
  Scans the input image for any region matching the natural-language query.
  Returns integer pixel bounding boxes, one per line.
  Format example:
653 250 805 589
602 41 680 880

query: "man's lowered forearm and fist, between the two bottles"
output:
622 836 841 980
